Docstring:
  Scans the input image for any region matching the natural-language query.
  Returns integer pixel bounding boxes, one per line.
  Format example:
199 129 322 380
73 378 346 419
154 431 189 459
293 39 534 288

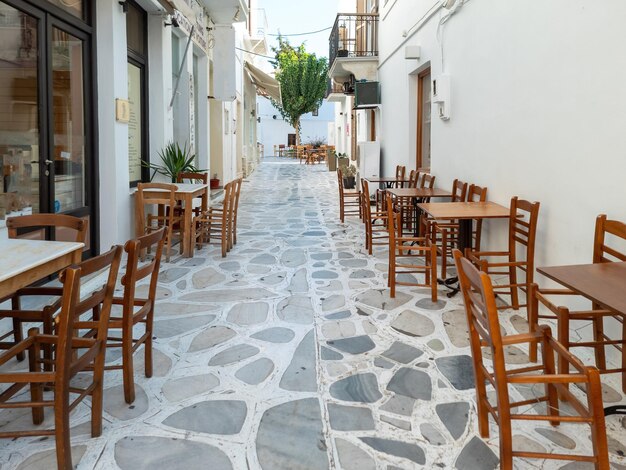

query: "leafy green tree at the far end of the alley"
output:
271 36 328 145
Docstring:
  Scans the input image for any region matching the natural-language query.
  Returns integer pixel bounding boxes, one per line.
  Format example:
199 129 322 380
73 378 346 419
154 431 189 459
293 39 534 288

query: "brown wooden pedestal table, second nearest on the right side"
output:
417 201 510 297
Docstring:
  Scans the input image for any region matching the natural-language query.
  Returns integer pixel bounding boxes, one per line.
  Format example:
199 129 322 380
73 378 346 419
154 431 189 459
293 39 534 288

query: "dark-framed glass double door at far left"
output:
0 0 97 254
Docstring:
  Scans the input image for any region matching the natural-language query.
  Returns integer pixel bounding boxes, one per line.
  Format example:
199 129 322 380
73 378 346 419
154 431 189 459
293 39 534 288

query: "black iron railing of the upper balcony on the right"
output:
328 13 378 66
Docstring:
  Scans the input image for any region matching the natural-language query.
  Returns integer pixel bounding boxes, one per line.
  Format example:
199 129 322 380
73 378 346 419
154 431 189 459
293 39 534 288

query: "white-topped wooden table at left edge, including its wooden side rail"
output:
0 239 85 298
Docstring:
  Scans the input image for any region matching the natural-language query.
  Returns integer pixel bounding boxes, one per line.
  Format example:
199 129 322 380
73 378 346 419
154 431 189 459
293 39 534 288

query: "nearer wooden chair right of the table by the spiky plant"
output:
193 180 237 258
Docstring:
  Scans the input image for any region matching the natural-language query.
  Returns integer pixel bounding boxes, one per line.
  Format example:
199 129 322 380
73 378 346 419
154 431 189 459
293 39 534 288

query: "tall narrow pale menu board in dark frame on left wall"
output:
128 63 142 183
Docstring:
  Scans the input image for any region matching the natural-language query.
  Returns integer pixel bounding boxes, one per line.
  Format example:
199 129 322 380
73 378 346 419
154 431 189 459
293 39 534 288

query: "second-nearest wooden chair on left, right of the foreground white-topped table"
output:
106 227 167 403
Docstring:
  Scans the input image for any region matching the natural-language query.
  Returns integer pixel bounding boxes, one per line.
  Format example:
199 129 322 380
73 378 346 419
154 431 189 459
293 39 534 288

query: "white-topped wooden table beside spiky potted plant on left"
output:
135 183 209 258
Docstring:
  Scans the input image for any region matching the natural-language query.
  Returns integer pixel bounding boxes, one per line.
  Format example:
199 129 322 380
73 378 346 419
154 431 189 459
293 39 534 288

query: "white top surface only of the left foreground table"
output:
0 239 85 282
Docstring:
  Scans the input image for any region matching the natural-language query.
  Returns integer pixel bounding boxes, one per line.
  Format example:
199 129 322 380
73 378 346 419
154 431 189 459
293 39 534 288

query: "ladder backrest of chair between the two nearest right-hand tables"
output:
509 196 539 268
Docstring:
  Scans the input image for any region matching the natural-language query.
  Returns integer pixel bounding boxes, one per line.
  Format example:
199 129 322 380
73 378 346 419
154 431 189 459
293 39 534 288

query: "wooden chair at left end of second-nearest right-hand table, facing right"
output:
387 194 437 302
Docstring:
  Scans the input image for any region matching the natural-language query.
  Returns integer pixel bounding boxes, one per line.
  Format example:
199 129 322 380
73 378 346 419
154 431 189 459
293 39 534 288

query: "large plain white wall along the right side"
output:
379 0 626 276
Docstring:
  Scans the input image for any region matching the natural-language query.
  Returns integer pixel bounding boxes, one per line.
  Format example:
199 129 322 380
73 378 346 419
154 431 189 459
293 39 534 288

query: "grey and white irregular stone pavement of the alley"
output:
0 159 626 470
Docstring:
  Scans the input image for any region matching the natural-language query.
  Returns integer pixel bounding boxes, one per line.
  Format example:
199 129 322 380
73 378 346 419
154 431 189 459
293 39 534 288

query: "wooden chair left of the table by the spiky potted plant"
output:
136 183 183 262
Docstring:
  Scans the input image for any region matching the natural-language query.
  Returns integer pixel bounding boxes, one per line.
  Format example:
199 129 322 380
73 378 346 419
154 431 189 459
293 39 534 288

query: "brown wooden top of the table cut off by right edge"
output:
537 262 626 313
